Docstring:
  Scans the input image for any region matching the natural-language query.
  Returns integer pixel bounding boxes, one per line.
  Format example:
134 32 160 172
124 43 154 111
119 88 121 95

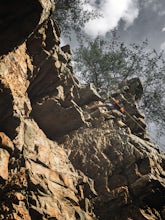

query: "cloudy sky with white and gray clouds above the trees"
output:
85 0 165 50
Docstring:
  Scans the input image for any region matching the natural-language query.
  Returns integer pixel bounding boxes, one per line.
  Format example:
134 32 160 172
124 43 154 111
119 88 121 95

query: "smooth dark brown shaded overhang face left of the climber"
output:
33 98 87 139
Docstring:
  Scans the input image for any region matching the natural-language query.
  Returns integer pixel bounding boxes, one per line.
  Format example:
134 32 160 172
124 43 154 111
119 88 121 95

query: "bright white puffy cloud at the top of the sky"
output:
85 0 139 36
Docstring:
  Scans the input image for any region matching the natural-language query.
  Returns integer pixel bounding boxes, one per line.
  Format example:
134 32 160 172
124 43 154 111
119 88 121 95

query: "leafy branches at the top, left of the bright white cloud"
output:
54 0 99 38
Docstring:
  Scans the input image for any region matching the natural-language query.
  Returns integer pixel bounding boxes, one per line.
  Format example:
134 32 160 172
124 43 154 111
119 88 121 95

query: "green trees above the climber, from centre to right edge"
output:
74 32 165 141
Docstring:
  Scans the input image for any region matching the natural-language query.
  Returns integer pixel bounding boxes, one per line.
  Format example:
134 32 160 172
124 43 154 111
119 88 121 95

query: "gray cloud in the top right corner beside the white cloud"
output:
114 0 165 51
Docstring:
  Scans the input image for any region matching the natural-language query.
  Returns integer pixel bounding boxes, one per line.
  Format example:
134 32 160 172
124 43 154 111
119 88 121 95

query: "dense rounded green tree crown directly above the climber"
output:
74 32 147 88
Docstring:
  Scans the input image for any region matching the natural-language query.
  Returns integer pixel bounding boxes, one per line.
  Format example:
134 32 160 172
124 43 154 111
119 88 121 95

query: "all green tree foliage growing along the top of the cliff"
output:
55 0 165 148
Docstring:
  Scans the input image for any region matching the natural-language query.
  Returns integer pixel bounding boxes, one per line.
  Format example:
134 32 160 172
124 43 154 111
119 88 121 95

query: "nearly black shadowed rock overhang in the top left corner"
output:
0 0 42 55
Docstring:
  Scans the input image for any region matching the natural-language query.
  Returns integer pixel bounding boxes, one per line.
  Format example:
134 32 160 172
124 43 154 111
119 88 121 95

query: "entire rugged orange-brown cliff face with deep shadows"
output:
0 0 165 220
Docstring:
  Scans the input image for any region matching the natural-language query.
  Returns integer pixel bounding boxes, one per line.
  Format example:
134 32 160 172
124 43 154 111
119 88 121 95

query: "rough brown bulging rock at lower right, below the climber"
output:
63 121 165 220
